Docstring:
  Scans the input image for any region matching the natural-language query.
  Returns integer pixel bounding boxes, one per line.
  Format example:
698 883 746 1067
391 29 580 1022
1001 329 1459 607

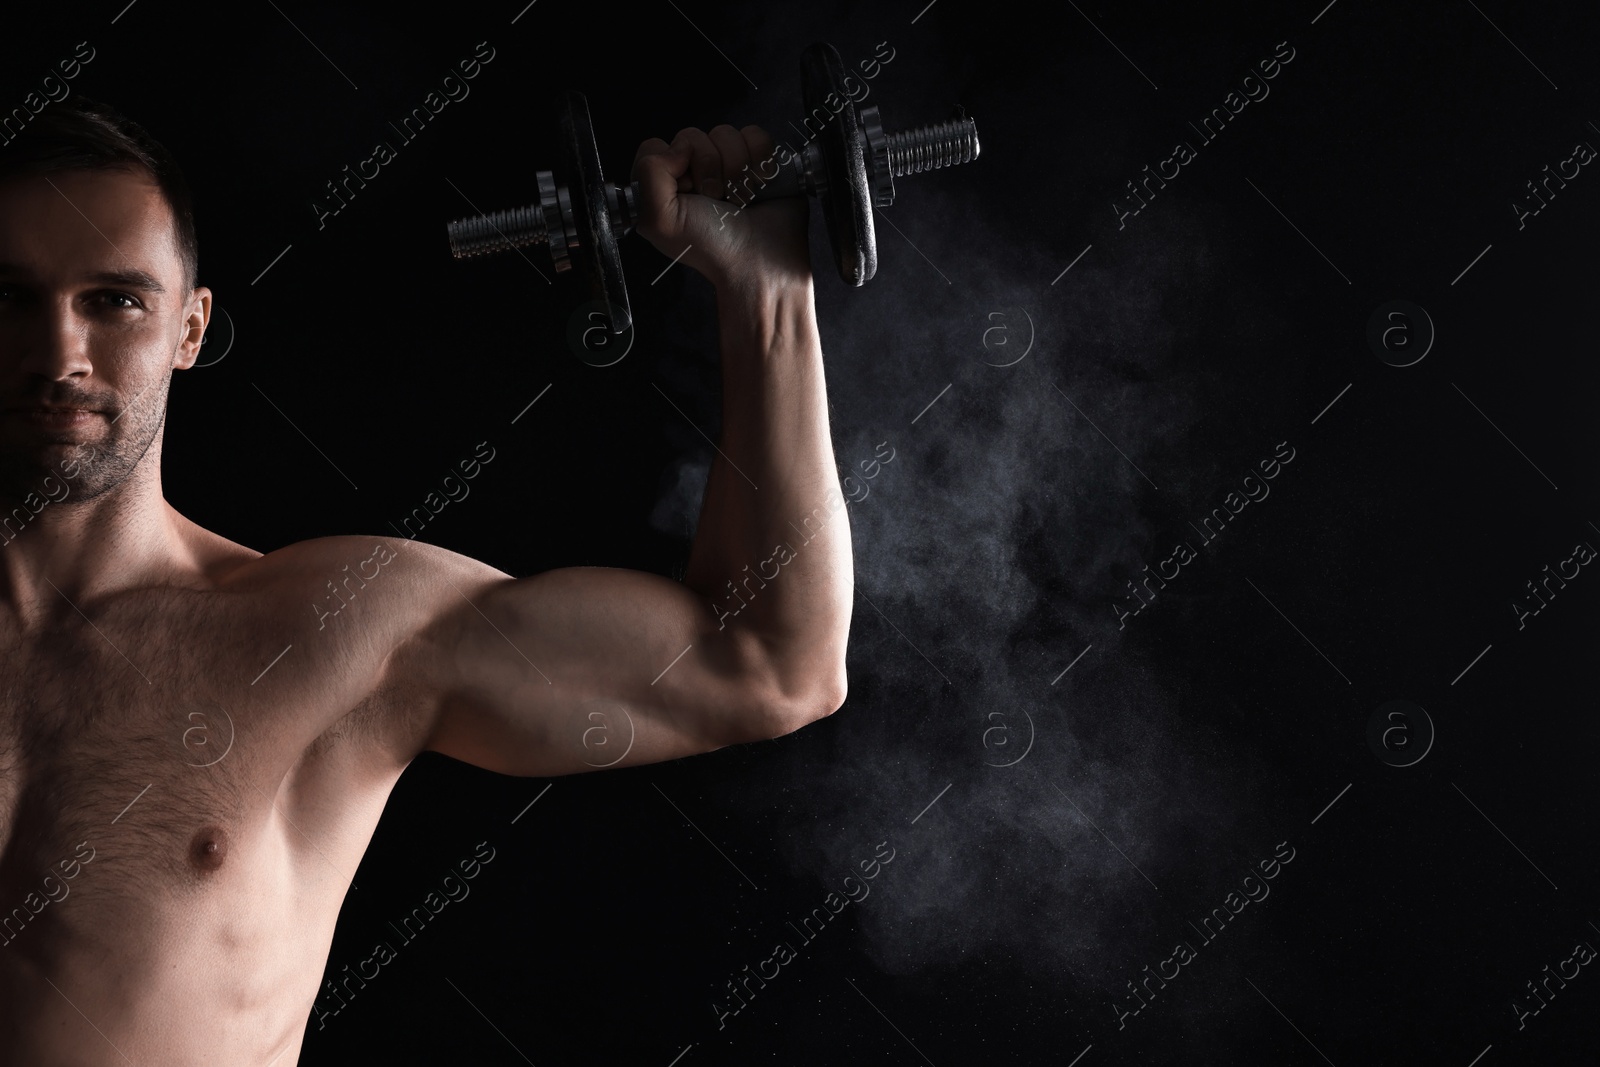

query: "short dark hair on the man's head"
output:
0 94 200 290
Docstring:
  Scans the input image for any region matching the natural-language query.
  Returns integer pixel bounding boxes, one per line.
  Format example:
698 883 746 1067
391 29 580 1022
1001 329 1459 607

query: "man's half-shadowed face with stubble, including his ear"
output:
0 171 211 501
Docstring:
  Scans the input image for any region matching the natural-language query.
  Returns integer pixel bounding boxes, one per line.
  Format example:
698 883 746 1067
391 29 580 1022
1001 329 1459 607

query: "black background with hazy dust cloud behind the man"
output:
12 0 1600 1067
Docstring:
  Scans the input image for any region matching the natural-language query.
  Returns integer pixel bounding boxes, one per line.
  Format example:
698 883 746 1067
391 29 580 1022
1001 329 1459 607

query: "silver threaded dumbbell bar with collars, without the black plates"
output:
448 107 979 262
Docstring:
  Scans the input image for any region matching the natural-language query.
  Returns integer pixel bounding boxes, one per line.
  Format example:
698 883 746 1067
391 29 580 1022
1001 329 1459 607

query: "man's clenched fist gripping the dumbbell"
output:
634 125 811 299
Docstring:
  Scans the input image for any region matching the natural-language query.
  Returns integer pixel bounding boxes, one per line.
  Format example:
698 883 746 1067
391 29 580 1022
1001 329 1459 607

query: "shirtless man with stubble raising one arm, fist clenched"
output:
0 99 853 1067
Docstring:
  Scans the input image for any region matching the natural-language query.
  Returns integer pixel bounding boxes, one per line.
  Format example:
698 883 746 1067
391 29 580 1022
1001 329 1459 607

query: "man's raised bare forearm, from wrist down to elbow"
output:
683 277 853 697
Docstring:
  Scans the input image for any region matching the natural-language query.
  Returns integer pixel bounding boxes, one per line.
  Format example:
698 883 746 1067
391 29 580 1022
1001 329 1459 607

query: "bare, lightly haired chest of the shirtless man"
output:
0 592 398 934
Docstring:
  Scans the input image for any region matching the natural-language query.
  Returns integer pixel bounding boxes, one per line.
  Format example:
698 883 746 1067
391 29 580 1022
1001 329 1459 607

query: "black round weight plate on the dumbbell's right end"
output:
800 42 878 285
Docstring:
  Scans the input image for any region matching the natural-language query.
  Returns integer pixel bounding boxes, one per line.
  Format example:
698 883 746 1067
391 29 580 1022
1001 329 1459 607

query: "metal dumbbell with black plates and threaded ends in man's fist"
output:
448 42 978 333
